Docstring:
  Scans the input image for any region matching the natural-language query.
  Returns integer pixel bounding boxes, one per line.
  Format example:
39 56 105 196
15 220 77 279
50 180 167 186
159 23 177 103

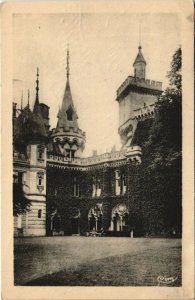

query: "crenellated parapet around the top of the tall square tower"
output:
117 76 162 98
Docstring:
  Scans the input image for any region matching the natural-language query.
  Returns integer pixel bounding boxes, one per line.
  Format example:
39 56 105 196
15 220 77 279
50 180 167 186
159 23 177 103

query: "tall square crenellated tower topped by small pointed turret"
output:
116 45 163 149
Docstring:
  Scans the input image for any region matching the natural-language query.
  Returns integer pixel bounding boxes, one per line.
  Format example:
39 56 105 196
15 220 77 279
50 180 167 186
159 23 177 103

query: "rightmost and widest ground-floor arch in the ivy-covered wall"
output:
111 204 129 231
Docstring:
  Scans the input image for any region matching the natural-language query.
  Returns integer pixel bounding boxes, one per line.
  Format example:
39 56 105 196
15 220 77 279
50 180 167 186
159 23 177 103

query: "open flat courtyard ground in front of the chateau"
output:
14 236 182 286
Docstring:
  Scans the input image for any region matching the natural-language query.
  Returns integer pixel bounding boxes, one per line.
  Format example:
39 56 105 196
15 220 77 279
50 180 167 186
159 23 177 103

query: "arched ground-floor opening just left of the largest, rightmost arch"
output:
88 204 103 231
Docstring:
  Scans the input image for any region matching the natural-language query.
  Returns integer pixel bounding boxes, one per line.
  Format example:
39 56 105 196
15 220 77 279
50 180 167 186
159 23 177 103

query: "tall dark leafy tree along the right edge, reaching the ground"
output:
143 48 182 232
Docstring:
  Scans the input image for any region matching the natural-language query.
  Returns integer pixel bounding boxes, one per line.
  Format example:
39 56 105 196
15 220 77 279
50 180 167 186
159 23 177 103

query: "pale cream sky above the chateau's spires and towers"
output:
13 13 181 156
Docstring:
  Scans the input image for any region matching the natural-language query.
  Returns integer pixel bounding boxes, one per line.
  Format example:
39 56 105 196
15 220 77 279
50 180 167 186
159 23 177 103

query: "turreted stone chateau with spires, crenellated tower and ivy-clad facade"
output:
13 46 162 236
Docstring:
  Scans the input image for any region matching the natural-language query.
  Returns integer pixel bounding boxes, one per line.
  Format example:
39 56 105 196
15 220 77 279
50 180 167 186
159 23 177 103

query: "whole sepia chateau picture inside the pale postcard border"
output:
1 0 193 299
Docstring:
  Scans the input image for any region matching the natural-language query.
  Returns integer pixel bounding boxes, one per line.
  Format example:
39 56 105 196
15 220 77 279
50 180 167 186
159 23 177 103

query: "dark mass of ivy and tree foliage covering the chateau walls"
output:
47 49 182 236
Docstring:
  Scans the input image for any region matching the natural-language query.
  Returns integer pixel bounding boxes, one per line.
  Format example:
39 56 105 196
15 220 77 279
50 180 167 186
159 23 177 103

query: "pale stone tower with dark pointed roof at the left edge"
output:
14 68 47 236
